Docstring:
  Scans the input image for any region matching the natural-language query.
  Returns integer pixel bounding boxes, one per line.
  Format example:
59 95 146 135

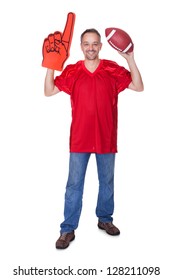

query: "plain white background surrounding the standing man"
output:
0 0 173 279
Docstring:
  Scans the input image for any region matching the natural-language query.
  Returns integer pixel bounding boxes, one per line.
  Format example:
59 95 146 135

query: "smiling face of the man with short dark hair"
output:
81 33 102 60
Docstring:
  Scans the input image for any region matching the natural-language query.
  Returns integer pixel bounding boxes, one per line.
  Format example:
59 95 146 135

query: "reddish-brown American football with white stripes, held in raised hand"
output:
105 27 134 53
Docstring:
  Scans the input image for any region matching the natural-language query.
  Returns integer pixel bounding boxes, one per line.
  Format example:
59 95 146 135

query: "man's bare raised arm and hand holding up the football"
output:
118 52 144 91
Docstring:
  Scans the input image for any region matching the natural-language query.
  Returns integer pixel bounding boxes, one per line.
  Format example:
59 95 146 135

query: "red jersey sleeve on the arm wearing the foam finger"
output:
54 64 75 94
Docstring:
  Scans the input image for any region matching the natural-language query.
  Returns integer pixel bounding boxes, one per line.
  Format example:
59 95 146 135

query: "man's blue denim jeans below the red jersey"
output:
60 153 115 233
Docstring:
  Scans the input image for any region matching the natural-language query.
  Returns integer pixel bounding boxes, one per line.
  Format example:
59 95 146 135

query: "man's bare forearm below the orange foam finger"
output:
44 69 60 96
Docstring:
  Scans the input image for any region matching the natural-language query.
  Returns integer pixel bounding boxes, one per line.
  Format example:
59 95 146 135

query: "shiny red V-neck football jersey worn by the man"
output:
54 60 131 154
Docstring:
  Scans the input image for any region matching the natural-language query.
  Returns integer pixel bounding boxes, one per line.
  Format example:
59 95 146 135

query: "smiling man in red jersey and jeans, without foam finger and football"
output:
45 29 143 249
